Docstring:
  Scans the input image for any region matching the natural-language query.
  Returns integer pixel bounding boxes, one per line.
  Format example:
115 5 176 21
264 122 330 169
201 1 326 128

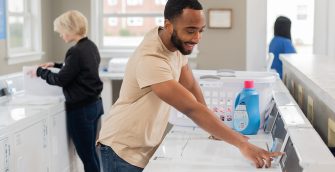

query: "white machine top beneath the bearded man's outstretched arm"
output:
144 126 281 172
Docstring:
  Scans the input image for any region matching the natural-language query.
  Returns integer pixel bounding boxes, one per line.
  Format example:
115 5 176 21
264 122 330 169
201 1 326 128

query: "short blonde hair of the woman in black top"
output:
54 10 88 36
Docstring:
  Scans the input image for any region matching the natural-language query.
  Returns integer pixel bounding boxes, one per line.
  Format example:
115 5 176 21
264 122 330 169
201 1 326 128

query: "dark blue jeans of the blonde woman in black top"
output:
66 99 103 172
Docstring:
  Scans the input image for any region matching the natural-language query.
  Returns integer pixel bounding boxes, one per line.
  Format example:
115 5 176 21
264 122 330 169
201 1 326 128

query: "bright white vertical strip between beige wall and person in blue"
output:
246 0 267 70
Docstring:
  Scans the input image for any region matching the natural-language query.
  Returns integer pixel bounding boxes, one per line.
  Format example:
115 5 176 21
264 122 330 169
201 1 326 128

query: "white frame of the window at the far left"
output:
6 0 44 64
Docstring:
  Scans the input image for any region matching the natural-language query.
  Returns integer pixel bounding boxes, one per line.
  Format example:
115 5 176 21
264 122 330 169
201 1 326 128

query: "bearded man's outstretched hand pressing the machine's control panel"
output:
238 142 283 168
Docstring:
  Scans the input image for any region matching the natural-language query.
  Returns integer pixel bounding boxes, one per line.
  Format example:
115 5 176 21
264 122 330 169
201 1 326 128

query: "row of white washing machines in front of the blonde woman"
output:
0 74 83 172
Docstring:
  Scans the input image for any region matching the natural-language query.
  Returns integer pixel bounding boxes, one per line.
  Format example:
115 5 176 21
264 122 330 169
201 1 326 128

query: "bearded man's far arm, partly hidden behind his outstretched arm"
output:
179 64 207 106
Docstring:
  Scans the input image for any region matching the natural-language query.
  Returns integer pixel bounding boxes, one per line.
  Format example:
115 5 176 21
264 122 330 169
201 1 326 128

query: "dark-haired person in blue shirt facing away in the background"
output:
269 16 296 79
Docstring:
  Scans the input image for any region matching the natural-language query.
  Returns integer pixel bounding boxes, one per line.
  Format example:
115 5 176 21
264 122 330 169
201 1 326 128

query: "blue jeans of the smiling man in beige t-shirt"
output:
100 145 143 172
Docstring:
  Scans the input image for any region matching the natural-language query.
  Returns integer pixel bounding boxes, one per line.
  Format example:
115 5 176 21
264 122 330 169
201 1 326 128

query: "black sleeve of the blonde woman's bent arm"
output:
36 51 80 87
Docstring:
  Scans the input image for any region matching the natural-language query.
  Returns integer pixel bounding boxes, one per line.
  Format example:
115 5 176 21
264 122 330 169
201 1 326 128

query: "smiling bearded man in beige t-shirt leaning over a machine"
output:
98 0 280 172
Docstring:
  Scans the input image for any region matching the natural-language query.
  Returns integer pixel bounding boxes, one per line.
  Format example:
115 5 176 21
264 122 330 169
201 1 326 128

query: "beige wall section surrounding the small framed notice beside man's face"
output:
196 0 246 70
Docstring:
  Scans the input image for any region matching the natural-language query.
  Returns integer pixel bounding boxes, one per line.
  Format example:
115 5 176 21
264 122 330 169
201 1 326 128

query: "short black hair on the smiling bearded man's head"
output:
164 0 202 20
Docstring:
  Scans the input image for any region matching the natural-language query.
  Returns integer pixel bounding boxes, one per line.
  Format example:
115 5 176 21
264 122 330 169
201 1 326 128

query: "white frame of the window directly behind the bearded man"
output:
90 0 199 58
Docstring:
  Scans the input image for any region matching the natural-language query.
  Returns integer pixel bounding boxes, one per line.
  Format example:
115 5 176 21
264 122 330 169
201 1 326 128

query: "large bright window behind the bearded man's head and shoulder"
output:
90 0 198 58
